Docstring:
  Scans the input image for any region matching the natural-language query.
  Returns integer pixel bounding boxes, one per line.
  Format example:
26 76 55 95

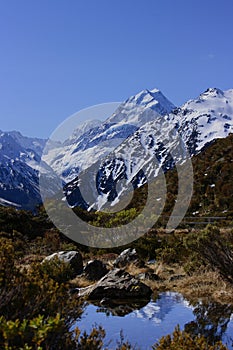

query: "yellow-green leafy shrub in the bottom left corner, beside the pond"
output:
0 314 110 350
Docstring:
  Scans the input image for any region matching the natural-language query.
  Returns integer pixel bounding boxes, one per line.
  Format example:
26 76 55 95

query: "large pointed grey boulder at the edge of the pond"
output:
79 269 152 300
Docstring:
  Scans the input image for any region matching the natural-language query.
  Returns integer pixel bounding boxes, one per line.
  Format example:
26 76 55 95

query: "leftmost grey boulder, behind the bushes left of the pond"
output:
43 250 83 274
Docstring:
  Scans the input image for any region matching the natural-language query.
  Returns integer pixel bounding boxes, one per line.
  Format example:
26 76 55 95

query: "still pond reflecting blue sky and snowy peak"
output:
75 292 233 350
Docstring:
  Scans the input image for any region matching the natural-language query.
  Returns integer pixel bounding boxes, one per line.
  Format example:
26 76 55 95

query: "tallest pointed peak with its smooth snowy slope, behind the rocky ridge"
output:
43 89 175 183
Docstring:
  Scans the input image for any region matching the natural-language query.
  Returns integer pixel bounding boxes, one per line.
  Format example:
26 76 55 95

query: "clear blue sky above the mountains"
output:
0 0 233 137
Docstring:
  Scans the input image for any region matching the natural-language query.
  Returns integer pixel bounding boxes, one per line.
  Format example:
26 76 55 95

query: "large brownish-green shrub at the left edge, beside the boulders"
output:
0 239 82 321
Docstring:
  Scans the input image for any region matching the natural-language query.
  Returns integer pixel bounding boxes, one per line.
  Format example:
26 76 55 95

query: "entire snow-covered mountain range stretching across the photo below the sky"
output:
0 88 233 213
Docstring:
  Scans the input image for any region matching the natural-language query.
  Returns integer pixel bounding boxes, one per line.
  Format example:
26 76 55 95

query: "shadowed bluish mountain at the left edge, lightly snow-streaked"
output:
0 131 58 209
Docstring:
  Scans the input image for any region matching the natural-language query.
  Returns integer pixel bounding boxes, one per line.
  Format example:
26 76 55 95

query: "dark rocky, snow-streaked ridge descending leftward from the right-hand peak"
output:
61 88 233 210
